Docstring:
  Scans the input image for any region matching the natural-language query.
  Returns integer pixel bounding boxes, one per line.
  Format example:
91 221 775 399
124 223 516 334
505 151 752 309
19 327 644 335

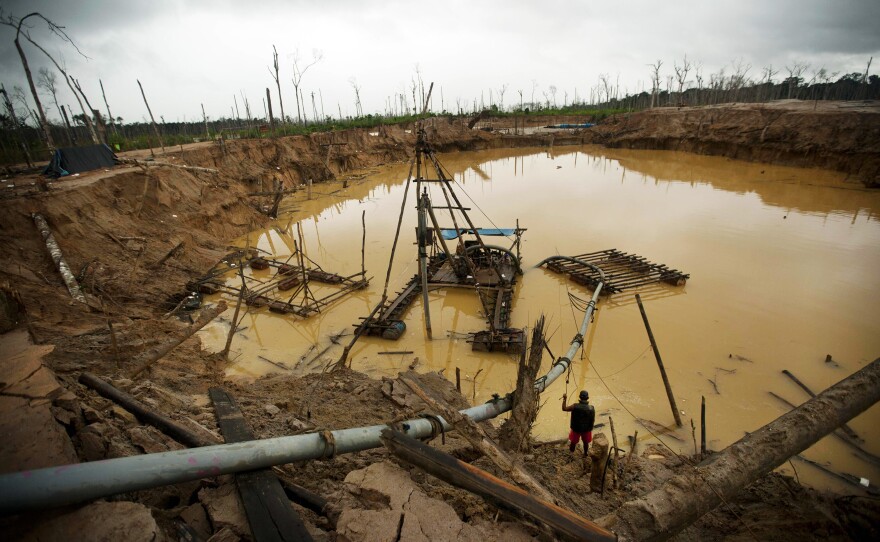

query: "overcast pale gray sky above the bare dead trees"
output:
0 0 880 121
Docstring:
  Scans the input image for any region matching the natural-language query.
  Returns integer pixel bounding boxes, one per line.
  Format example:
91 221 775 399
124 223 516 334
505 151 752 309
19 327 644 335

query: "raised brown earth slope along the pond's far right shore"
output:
585 100 880 186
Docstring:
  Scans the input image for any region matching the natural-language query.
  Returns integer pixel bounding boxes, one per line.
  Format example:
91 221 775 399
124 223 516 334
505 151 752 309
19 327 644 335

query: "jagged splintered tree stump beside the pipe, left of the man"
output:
498 315 544 452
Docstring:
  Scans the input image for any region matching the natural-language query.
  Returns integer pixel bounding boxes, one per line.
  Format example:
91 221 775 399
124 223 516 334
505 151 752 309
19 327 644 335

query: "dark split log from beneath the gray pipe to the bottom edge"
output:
382 429 615 542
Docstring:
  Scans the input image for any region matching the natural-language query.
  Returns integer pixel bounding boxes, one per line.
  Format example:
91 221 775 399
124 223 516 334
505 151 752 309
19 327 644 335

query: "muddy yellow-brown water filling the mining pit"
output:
202 146 880 498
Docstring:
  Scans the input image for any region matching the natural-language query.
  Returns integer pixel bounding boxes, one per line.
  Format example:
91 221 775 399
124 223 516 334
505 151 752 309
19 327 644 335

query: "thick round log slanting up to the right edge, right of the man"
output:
597 358 880 540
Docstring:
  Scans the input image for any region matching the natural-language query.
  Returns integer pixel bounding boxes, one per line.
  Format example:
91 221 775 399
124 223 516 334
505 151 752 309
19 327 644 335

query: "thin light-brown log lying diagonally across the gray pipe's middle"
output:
400 376 557 503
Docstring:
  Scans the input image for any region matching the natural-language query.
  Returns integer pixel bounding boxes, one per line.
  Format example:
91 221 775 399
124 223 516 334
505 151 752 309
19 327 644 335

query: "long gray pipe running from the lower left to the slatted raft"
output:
0 262 604 515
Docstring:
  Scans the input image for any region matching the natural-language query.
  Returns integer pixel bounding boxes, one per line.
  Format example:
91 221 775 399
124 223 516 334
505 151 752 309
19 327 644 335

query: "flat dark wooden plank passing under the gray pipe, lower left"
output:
208 388 312 542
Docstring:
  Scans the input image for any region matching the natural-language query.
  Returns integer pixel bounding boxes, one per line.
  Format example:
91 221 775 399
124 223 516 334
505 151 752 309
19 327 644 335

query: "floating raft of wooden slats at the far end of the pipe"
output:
545 252 690 295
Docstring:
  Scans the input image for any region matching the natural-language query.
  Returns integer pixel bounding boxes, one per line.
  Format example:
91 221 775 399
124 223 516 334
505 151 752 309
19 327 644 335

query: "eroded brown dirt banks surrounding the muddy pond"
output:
0 103 880 540
